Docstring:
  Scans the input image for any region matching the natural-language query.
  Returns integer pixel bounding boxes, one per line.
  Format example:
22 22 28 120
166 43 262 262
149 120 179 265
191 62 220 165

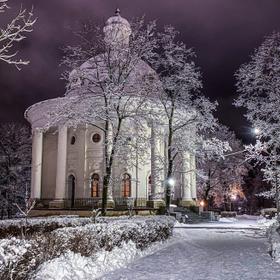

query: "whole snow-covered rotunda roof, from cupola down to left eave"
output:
24 9 159 128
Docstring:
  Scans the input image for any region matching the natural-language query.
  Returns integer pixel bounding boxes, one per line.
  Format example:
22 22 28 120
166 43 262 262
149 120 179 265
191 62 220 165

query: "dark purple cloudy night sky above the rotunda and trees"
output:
0 0 280 142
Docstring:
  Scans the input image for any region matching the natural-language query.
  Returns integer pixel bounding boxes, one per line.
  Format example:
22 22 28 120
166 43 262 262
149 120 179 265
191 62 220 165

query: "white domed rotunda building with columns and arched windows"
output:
25 11 196 212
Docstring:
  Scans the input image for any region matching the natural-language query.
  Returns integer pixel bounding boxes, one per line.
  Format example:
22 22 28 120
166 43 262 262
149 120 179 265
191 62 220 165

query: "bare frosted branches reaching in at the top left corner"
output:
0 0 36 70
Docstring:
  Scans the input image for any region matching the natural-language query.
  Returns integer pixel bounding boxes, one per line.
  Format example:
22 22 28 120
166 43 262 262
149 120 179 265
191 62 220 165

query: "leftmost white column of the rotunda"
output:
31 130 43 198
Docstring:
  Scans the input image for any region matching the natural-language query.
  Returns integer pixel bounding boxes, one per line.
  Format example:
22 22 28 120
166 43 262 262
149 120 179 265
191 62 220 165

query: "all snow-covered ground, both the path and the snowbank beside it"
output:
3 216 280 280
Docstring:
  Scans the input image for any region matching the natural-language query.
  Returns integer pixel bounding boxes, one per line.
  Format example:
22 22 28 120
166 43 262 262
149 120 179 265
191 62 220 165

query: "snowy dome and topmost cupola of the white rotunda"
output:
66 9 158 96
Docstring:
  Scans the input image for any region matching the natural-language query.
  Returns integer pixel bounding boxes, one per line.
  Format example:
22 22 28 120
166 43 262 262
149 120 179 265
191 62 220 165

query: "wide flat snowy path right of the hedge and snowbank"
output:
100 228 280 280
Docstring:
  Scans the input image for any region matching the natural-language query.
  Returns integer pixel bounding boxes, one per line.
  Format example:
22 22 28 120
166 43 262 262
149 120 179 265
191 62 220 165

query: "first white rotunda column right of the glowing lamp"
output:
182 152 192 201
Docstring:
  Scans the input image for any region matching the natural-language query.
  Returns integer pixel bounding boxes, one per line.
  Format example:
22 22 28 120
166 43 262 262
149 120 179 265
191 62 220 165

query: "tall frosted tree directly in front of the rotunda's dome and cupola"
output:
46 17 157 215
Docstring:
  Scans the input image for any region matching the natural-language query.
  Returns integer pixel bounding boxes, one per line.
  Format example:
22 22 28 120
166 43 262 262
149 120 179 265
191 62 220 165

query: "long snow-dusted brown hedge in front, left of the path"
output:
0 216 175 280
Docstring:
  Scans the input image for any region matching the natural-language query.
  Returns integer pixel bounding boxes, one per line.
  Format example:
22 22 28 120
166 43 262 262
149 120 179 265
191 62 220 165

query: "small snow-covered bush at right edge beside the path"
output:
268 221 280 262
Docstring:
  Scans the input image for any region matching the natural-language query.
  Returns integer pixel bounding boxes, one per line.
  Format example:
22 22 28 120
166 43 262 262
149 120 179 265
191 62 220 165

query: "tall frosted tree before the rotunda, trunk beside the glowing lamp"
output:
153 26 216 209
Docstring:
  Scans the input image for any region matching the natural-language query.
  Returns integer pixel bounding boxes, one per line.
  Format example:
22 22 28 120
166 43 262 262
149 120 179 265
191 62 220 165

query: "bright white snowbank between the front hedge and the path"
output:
32 238 165 280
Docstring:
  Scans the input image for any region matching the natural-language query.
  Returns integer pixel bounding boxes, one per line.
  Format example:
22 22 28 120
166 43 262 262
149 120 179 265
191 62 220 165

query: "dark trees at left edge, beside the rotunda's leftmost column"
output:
0 123 31 218
